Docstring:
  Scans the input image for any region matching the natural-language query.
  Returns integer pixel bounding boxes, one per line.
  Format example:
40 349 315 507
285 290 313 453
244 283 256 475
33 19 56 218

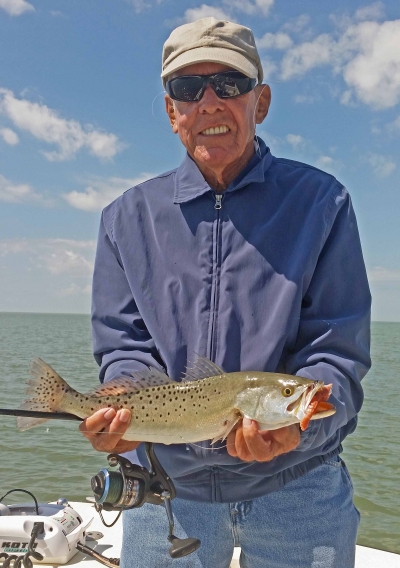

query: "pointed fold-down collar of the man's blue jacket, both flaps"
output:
174 138 272 203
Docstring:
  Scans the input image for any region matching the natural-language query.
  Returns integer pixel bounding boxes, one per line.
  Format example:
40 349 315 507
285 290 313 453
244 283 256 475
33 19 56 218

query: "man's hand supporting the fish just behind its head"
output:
227 418 300 462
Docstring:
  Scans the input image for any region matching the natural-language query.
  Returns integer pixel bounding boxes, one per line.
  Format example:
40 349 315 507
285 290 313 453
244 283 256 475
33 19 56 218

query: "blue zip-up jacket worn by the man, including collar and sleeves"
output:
93 140 370 502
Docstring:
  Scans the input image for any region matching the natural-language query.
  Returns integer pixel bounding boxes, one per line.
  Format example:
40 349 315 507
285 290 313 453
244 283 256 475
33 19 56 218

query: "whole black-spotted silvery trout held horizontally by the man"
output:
17 357 335 444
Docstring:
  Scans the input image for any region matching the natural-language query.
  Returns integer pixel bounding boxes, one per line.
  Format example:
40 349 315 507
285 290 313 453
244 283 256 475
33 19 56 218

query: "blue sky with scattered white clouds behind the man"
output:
0 0 400 321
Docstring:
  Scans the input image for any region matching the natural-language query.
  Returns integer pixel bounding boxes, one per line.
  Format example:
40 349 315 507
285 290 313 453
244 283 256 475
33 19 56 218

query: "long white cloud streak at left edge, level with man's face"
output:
0 89 123 161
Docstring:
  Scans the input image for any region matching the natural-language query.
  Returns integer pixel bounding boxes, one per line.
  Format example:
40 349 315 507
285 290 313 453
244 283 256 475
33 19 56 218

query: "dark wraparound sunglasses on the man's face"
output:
165 71 257 103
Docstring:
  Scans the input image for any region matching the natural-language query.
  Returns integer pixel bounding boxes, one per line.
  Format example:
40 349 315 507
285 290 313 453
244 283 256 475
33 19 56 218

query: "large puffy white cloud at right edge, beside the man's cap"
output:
281 20 400 109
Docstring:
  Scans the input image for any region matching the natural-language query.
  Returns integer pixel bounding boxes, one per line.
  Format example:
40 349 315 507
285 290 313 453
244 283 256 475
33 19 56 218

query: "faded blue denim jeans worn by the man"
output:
121 456 359 568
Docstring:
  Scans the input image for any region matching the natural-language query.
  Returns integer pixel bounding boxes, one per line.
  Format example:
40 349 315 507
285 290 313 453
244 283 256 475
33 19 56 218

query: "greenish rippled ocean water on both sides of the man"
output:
0 313 400 553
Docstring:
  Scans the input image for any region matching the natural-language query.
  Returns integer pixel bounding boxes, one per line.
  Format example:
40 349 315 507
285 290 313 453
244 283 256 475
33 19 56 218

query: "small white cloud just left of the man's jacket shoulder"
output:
63 173 153 211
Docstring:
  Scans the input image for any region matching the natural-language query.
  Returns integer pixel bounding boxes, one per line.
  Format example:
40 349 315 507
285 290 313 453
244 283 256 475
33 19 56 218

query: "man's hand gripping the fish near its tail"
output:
79 408 140 454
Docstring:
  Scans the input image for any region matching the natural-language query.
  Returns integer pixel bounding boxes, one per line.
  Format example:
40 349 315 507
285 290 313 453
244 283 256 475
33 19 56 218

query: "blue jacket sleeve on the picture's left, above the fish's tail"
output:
92 208 162 382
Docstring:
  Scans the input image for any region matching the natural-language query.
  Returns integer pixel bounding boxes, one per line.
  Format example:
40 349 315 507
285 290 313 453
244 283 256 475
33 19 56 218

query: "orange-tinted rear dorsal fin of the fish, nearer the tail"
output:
86 367 175 397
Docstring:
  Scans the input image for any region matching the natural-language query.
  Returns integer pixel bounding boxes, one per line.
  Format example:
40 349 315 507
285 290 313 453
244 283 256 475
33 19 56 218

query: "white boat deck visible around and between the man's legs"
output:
40 502 400 568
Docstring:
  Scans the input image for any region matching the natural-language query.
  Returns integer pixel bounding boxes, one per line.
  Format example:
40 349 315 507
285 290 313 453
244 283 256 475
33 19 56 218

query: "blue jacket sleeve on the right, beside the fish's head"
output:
287 186 371 450
